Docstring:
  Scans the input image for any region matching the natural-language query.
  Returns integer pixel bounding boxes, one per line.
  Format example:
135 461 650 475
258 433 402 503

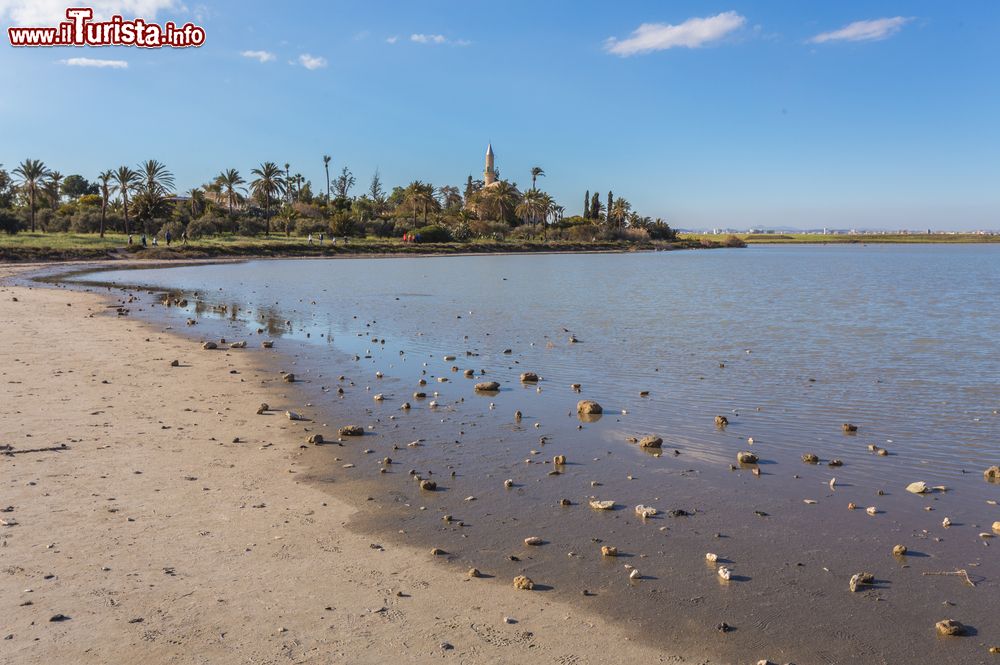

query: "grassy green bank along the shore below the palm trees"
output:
0 233 717 262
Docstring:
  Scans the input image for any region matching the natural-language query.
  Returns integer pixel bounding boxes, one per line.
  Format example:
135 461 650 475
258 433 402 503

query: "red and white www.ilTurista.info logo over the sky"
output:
7 7 205 48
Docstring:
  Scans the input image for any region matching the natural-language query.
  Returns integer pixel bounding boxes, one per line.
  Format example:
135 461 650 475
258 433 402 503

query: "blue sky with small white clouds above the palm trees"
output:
0 0 1000 229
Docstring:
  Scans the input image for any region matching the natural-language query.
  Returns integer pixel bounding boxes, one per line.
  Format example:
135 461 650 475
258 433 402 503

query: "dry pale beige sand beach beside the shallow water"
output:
0 269 685 664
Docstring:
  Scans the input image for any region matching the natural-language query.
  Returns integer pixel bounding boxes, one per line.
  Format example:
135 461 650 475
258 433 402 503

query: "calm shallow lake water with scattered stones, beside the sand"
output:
70 245 1000 663
